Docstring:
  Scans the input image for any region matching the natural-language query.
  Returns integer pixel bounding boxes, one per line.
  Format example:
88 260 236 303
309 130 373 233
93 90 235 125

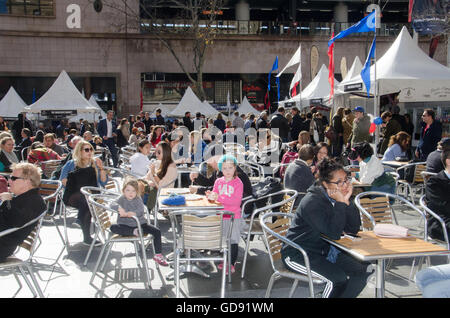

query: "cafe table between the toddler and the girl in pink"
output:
158 188 223 279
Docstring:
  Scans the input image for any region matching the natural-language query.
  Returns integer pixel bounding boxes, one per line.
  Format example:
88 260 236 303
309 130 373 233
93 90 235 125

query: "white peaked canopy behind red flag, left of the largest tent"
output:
280 64 339 107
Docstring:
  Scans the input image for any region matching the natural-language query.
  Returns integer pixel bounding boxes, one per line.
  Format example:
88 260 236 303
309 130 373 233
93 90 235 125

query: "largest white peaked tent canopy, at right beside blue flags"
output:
340 27 450 102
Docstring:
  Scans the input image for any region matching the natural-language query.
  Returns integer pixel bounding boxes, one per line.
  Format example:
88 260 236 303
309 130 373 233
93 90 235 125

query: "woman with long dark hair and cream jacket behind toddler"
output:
141 141 178 211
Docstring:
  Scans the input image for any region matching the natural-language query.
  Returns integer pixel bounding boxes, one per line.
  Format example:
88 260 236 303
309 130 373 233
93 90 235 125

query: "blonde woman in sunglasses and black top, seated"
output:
59 140 108 245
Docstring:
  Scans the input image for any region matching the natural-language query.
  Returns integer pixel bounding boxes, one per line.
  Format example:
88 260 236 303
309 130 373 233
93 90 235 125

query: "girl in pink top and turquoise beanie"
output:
206 155 244 273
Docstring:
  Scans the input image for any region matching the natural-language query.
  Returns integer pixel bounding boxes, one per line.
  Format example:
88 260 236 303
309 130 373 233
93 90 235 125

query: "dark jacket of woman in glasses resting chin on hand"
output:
282 184 361 257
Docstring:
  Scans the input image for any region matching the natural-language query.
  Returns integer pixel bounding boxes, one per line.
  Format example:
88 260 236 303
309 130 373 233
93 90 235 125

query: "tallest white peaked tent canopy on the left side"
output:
26 70 96 113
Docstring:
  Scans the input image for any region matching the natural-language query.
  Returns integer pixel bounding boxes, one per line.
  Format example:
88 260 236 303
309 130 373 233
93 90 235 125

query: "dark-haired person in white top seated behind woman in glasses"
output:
348 142 395 194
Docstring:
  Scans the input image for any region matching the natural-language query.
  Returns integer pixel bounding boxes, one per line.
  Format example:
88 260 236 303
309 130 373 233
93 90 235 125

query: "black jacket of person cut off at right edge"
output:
425 171 450 240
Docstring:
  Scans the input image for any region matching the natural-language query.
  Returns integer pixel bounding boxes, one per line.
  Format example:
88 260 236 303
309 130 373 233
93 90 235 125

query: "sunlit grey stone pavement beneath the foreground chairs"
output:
0 201 446 298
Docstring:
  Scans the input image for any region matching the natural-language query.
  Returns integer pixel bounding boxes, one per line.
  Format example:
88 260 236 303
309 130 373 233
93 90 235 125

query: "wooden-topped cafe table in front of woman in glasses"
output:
322 231 450 298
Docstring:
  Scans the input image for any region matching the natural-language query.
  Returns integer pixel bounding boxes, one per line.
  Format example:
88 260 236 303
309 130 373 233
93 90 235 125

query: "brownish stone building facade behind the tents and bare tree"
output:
0 0 448 116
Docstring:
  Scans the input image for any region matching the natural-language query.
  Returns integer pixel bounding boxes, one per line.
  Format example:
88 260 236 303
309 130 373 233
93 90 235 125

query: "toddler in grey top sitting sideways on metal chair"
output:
111 178 168 266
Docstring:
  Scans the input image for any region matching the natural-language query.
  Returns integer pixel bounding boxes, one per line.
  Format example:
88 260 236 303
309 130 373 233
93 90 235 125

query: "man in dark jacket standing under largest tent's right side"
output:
416 108 442 161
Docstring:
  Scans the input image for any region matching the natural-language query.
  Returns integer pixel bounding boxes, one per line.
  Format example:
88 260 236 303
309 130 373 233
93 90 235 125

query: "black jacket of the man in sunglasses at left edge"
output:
0 189 46 257
